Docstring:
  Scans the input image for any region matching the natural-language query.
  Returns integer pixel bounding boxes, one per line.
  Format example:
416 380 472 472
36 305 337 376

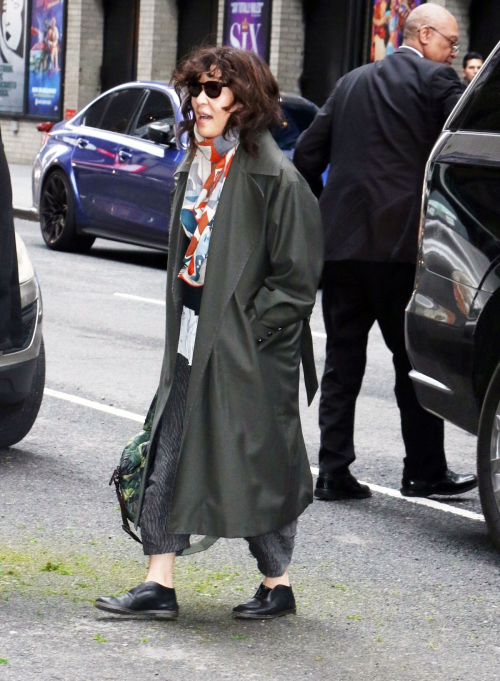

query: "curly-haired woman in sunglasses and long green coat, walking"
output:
96 47 323 619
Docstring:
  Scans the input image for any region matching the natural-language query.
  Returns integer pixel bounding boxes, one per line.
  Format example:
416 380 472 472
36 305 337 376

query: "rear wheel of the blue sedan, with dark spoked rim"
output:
40 170 95 253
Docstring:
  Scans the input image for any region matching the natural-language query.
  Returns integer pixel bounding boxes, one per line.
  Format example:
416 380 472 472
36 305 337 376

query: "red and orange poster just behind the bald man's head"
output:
370 0 425 61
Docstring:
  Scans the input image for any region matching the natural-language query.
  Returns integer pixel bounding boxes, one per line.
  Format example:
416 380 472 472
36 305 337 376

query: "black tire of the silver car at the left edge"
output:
0 340 45 449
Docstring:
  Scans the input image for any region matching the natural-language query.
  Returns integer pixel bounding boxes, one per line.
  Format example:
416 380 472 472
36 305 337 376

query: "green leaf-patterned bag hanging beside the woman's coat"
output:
109 394 158 544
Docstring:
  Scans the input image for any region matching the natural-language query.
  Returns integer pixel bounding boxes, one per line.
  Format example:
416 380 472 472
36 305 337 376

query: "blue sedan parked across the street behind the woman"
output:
33 82 317 252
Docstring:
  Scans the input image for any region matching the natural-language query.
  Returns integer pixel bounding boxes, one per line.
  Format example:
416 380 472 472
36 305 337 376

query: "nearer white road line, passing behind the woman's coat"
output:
44 388 484 522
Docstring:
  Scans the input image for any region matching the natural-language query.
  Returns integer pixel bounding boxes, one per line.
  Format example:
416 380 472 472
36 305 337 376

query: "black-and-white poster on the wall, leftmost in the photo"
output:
0 0 28 113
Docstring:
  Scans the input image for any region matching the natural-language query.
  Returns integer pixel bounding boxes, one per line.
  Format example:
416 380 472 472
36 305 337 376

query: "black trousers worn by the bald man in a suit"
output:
319 260 447 481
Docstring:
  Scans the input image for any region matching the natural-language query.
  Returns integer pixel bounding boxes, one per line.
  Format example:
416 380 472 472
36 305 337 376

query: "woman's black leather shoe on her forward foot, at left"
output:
95 582 179 620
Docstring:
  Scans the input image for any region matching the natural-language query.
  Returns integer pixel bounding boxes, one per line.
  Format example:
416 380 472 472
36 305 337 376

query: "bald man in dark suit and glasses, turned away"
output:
294 3 477 500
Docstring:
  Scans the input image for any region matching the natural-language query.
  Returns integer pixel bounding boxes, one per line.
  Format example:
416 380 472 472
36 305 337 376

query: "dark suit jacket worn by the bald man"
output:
294 48 464 263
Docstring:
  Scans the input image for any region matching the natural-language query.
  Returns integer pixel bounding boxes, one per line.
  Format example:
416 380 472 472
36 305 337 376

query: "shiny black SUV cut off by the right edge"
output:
406 39 500 548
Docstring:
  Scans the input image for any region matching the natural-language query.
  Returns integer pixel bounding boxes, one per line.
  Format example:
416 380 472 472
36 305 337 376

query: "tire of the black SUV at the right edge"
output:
477 364 500 549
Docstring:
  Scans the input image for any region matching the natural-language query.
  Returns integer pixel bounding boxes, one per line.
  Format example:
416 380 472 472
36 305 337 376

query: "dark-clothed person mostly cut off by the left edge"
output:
0 126 22 352
